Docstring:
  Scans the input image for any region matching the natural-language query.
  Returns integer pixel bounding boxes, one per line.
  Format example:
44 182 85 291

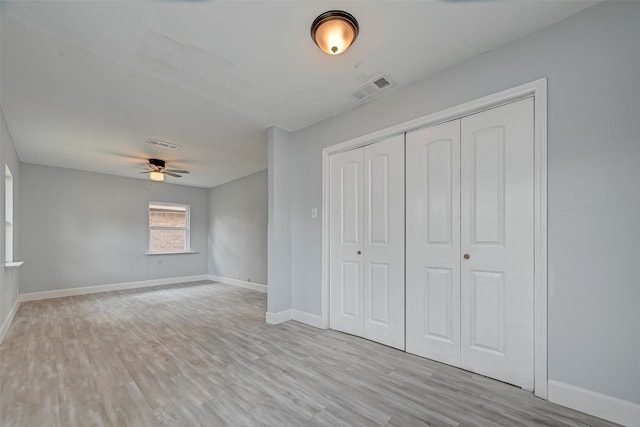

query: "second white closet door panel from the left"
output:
363 135 404 349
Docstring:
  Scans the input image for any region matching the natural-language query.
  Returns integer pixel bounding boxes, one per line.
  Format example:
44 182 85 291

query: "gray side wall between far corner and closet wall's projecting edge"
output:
209 170 267 285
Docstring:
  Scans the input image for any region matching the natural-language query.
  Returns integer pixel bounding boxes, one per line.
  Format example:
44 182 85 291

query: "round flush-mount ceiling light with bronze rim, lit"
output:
311 10 359 55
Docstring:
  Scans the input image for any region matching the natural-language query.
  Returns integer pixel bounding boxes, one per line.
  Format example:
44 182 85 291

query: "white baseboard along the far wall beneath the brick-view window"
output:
18 274 209 301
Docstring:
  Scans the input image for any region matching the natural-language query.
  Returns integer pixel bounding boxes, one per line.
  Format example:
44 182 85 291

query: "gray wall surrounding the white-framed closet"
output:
269 2 640 403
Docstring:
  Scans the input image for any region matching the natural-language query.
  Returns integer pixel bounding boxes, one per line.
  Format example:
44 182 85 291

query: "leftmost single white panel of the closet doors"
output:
329 149 364 336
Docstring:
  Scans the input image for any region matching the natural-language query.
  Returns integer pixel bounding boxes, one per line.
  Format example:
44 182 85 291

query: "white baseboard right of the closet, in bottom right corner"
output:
549 380 640 427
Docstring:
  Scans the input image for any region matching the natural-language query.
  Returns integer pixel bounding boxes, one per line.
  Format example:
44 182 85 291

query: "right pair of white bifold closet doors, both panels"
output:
406 98 534 389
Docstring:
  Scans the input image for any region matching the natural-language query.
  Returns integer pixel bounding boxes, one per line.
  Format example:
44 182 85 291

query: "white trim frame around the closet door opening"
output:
321 77 548 399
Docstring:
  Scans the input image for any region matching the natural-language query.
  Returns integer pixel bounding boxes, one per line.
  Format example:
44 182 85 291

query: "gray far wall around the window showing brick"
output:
20 164 209 292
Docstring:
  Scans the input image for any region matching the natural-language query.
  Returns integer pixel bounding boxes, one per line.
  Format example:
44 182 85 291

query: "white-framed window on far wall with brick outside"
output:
149 202 190 253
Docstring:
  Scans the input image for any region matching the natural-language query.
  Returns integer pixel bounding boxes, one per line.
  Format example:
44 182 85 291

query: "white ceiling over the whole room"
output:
0 0 594 187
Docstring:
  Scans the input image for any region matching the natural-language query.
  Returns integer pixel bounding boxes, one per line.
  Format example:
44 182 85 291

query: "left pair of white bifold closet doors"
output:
329 135 405 349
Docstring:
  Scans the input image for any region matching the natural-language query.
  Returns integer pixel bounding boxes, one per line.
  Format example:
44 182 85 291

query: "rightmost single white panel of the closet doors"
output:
461 98 534 390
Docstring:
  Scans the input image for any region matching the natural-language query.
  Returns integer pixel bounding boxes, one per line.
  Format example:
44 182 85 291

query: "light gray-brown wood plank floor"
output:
0 282 613 427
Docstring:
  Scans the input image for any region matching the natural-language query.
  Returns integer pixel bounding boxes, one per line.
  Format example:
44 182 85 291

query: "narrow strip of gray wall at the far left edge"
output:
0 108 22 332
